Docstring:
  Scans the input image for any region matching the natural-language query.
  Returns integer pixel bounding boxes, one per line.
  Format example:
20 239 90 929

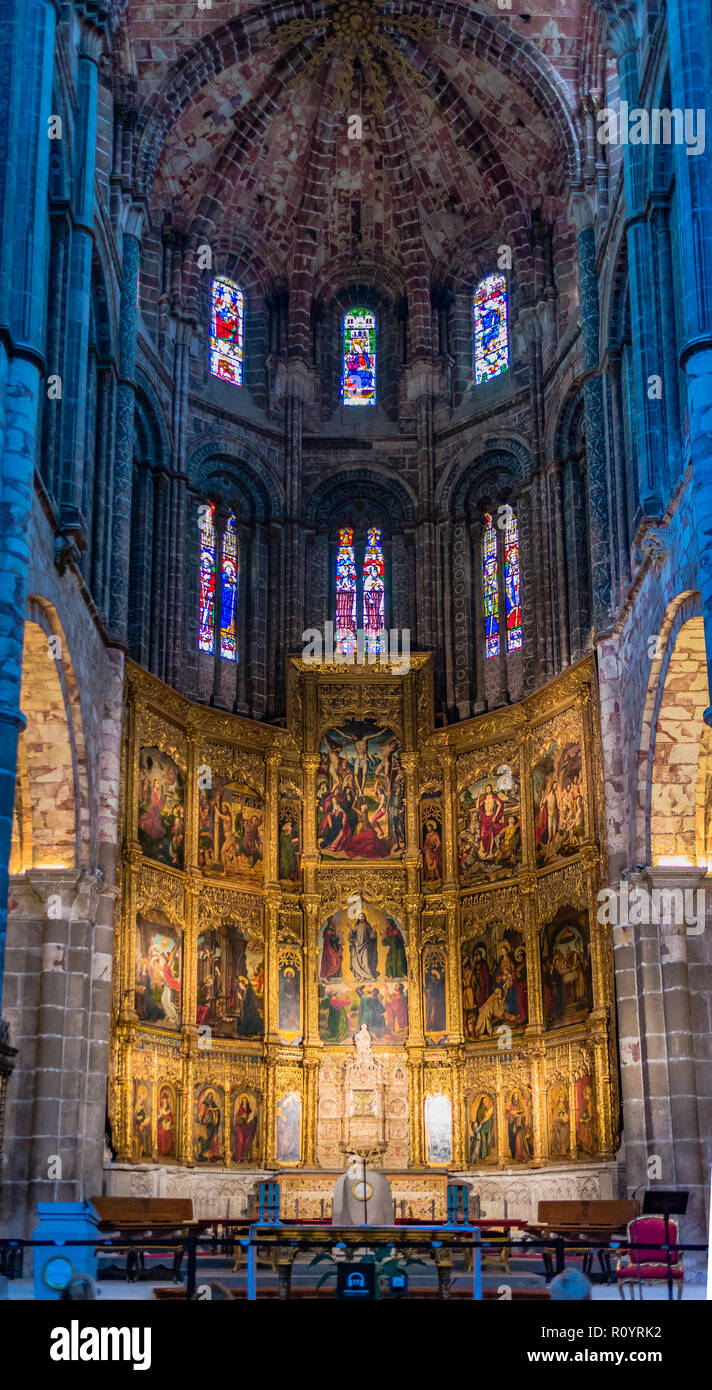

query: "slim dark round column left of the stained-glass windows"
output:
110 206 143 646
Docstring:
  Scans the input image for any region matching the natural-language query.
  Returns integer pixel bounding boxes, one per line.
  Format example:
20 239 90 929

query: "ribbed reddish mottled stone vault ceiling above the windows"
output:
114 0 602 290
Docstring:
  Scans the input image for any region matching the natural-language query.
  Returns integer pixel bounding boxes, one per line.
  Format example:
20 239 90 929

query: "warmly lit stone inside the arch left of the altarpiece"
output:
13 596 89 873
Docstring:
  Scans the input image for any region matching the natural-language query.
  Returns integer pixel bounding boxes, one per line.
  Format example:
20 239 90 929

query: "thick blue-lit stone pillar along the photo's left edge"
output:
0 0 56 1023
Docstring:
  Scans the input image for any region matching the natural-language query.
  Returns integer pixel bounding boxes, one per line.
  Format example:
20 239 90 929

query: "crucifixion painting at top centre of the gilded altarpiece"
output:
317 719 406 862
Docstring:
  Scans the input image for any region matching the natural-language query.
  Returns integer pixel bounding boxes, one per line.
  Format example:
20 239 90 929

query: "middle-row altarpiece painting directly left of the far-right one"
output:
462 923 528 1043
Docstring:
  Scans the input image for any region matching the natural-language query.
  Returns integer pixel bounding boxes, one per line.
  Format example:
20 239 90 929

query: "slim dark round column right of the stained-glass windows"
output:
570 189 612 632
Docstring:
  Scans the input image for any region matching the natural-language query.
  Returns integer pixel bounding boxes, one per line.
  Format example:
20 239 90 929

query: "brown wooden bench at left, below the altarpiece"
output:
92 1197 196 1282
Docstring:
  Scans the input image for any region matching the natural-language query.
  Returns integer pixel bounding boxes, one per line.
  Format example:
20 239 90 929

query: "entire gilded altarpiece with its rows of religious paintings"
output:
110 653 619 1180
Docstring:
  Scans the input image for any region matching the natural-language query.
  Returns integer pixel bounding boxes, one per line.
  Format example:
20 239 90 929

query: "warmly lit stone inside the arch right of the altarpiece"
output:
636 591 709 865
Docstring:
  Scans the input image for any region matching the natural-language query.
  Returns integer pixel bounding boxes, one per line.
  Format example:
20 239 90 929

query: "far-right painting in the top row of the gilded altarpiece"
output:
531 739 584 867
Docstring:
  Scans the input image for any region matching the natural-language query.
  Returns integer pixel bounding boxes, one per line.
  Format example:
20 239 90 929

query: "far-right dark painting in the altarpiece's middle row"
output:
541 908 591 1027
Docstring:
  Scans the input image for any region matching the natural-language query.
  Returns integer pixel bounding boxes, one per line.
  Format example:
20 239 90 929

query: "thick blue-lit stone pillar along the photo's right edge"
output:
668 0 712 724
